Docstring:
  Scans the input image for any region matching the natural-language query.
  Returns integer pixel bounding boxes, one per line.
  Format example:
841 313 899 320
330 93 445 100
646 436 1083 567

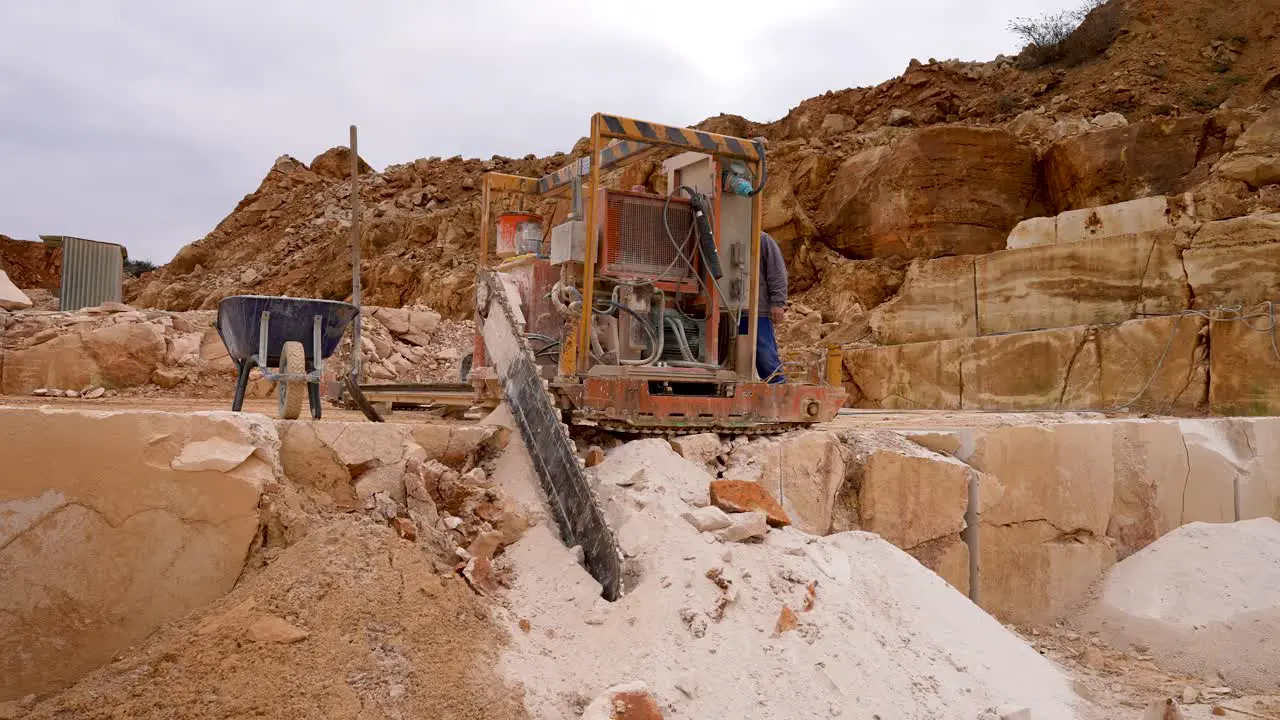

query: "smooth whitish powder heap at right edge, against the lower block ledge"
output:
1075 518 1280 693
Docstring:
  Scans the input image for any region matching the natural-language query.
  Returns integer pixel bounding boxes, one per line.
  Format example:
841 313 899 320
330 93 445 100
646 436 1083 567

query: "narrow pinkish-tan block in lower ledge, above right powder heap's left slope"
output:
1107 420 1190 559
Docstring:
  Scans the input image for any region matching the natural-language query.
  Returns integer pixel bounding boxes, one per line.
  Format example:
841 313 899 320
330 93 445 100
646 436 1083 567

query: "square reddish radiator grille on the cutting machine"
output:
602 191 698 282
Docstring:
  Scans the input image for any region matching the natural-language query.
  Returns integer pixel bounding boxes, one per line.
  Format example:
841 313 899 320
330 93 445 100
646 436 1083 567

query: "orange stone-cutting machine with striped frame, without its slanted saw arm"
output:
463 114 845 434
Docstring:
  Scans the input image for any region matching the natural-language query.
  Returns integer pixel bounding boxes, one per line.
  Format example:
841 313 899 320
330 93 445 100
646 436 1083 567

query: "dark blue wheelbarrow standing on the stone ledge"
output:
215 295 358 420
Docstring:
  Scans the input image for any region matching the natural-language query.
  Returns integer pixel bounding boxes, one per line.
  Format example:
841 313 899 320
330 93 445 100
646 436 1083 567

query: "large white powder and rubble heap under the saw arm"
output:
494 430 1079 719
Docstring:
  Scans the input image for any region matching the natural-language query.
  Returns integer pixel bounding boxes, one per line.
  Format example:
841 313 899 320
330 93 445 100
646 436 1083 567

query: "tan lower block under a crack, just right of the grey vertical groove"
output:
978 515 1116 625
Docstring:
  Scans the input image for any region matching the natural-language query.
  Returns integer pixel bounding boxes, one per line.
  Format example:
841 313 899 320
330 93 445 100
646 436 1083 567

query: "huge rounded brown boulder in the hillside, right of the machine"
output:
819 127 1036 258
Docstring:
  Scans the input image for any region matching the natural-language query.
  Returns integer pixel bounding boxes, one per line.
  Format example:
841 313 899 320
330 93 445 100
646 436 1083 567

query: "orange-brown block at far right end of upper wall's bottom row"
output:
1203 306 1280 415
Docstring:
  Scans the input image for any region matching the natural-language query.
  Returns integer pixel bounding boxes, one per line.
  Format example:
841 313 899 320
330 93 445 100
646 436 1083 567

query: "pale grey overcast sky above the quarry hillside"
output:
0 0 1069 263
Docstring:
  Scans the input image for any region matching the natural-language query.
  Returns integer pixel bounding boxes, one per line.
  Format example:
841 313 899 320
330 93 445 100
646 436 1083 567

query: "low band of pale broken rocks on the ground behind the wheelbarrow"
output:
0 302 474 398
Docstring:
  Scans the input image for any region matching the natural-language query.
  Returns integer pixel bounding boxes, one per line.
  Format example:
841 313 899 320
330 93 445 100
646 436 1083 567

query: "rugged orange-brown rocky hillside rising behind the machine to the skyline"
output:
127 0 1280 327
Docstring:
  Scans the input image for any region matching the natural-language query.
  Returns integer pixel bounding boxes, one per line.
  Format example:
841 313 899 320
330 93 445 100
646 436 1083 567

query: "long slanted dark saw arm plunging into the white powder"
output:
476 269 625 600
